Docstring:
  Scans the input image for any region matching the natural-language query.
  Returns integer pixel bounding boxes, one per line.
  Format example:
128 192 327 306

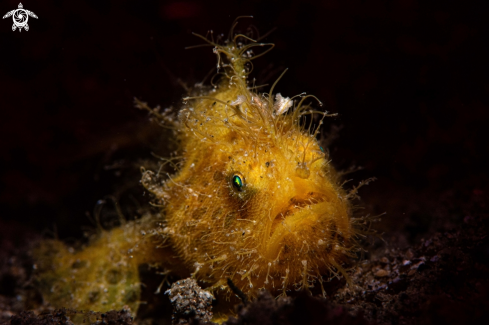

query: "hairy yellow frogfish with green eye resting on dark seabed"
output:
35 24 365 314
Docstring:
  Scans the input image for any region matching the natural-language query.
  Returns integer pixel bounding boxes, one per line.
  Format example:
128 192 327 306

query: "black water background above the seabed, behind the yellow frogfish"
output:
0 0 489 251
